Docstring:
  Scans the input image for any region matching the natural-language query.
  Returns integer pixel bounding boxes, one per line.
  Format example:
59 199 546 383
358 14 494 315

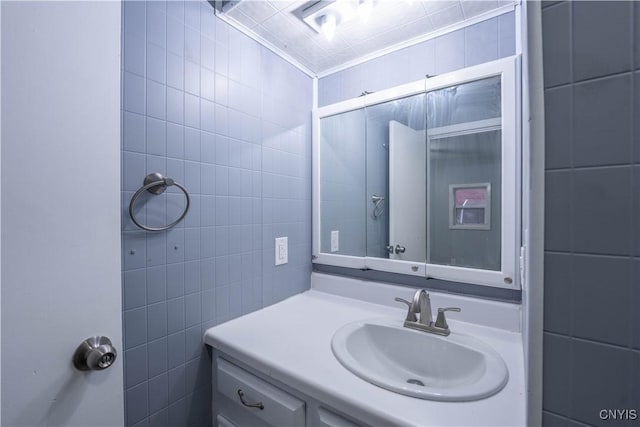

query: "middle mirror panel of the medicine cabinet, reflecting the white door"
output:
365 93 427 262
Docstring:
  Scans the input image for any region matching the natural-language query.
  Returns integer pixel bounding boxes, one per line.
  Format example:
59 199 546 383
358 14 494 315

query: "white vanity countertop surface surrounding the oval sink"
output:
205 273 526 426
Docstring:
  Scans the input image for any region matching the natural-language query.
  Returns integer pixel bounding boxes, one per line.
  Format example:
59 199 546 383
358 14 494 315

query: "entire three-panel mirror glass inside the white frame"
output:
320 76 502 271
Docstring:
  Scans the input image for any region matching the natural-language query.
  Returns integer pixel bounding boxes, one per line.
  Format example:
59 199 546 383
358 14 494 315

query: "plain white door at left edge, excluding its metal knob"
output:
0 1 124 426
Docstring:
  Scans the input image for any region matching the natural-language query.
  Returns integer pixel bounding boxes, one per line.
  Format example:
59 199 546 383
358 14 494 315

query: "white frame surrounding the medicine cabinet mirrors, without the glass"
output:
312 56 527 289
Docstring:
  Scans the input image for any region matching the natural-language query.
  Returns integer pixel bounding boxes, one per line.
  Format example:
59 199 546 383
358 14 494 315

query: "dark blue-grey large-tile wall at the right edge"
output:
542 1 640 426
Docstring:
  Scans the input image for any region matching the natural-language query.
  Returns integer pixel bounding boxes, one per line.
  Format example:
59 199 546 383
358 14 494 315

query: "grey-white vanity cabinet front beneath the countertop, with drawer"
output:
213 352 362 427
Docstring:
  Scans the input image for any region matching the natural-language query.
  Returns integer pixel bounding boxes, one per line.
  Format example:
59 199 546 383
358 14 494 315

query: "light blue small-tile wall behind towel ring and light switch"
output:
122 0 312 426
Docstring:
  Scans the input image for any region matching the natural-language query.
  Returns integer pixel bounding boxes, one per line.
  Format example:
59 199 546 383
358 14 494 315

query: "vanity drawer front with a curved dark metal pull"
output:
217 358 305 427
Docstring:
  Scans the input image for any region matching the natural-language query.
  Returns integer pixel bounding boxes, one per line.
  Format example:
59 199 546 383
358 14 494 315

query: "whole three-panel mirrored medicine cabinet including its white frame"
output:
313 57 521 289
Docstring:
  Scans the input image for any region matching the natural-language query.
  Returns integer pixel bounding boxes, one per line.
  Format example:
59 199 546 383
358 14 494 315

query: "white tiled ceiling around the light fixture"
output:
223 0 514 74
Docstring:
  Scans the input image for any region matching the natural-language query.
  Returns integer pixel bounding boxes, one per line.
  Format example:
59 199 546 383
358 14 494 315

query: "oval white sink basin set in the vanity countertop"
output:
331 318 509 401
